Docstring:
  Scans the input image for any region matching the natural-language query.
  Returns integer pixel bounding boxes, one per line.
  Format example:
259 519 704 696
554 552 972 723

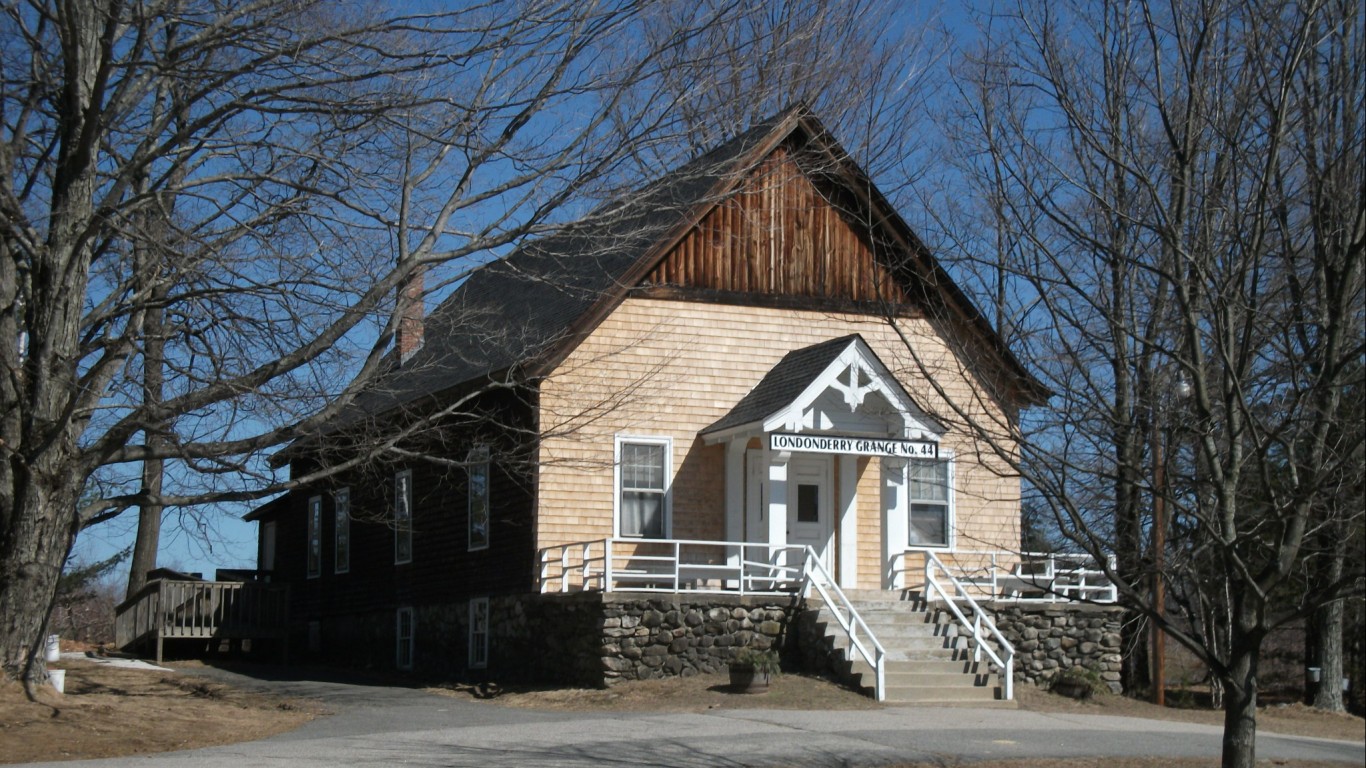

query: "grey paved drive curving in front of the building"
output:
16 671 1366 768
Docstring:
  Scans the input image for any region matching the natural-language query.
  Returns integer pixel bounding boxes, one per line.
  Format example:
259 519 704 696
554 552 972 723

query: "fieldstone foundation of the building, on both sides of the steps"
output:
294 592 1123 693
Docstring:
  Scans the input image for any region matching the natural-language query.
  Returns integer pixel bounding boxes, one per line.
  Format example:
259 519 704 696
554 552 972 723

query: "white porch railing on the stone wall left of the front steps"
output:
540 538 807 594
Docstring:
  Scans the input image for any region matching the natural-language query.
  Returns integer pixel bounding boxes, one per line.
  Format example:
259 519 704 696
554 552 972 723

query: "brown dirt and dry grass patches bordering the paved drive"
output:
0 650 1366 768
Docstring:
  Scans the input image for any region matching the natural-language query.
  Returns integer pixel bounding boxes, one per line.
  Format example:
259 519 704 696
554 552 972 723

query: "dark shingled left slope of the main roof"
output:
321 108 803 429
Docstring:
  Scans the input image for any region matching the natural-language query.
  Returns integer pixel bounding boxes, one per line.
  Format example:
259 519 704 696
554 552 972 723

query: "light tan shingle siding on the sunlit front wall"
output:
537 298 1019 588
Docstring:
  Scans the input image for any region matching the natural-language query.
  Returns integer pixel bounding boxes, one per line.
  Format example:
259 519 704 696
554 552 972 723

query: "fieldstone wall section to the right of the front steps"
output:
988 603 1124 693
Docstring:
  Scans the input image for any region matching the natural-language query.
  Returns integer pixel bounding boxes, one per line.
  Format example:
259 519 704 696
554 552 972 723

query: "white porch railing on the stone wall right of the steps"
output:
940 549 1119 603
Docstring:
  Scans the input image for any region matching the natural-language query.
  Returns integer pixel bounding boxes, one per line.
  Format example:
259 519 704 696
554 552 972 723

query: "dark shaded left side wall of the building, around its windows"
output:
276 395 534 622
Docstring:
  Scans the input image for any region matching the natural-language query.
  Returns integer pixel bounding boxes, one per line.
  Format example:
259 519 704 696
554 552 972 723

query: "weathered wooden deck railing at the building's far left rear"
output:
115 579 290 663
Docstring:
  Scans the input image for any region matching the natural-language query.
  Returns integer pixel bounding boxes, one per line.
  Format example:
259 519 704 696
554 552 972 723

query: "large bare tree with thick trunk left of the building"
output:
0 0 759 676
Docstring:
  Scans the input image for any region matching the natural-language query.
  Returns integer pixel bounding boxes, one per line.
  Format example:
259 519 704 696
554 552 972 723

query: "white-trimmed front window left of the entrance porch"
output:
616 437 673 538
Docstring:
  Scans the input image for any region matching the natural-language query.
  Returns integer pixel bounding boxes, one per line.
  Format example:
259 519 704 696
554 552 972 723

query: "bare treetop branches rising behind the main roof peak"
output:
603 0 945 197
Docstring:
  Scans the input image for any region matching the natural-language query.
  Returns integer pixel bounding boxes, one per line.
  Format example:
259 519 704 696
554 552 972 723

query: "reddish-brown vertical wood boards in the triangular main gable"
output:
642 149 907 302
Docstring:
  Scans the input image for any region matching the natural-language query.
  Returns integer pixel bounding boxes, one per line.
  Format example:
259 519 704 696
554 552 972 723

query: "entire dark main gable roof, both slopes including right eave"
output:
299 105 1048 448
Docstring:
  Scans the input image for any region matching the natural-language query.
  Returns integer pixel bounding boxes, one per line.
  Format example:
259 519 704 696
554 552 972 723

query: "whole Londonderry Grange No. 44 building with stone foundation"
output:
249 108 1098 697
